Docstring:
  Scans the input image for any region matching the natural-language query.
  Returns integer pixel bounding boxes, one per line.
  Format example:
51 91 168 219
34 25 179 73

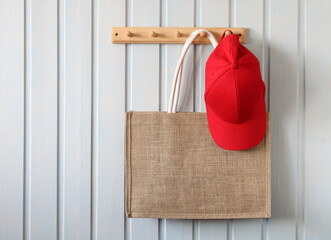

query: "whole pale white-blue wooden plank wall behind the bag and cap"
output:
0 0 331 240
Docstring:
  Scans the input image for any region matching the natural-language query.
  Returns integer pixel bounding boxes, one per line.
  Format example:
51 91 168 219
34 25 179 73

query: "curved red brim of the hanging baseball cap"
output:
206 101 267 150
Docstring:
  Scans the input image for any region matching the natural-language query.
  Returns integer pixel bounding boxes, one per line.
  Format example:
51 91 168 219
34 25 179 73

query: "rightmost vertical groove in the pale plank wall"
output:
295 0 306 240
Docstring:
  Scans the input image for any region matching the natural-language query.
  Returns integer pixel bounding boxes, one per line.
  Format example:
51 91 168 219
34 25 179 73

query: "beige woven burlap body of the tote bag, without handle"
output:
125 112 271 219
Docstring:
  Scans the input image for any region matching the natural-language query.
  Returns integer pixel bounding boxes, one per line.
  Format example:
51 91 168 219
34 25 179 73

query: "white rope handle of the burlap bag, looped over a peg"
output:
168 29 218 113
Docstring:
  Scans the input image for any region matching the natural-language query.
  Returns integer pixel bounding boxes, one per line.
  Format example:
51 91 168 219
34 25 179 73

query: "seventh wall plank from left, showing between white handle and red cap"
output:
194 0 229 240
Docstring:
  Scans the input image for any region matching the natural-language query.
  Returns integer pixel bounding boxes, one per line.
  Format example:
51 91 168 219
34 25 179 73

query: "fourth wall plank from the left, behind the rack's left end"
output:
92 0 125 240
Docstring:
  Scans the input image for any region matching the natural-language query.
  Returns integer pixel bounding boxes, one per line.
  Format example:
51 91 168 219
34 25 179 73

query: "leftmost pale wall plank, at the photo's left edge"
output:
0 0 25 239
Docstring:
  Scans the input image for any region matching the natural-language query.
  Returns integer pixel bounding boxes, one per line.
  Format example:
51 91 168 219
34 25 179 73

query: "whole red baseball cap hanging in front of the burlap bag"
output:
205 30 266 150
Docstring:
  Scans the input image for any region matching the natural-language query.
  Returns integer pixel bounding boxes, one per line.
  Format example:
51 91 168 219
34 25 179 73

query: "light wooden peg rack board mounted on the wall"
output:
112 27 246 44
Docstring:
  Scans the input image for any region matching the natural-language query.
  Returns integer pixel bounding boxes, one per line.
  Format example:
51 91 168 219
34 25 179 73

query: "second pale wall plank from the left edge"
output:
25 1 58 239
